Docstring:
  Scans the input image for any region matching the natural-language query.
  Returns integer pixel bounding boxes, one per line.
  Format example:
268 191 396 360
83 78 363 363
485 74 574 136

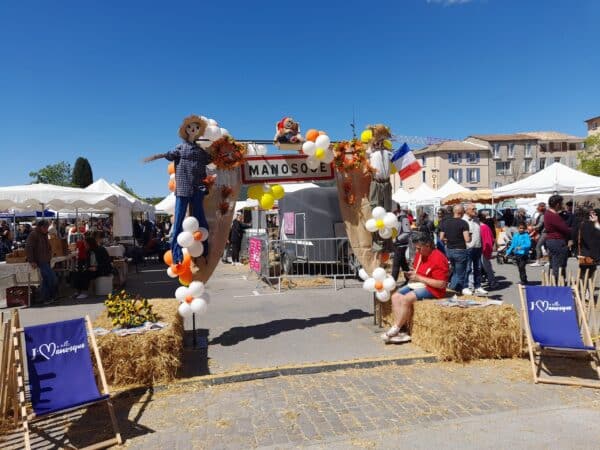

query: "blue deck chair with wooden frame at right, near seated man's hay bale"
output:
519 286 600 388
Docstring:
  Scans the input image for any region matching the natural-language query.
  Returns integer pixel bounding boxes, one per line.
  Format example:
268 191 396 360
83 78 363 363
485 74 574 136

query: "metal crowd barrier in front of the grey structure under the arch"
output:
248 235 360 291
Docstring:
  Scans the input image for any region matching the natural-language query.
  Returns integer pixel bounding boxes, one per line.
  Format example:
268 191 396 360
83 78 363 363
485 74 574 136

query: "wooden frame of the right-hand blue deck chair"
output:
519 286 600 389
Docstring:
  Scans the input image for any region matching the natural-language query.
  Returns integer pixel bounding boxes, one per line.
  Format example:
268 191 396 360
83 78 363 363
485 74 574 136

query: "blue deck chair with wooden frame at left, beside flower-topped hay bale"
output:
15 316 122 448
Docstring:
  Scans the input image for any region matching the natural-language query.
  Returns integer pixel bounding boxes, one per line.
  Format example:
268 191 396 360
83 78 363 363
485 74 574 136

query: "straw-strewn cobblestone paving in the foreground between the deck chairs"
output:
0 360 600 449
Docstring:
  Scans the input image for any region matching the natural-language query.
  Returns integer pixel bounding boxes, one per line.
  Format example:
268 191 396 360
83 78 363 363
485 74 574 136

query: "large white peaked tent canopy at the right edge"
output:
493 163 600 197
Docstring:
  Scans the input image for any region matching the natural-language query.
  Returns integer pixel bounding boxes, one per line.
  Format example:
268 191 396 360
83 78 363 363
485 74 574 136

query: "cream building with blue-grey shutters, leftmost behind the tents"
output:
392 141 490 192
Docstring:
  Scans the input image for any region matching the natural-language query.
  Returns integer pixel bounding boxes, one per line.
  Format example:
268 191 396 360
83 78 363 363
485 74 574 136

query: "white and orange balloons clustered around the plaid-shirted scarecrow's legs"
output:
163 217 208 286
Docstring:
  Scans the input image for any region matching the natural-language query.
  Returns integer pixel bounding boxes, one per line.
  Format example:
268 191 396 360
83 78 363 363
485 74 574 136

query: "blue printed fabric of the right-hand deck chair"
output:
525 286 595 351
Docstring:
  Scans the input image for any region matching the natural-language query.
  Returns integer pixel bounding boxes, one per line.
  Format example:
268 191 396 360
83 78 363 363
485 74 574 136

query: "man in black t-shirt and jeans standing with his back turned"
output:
440 205 472 295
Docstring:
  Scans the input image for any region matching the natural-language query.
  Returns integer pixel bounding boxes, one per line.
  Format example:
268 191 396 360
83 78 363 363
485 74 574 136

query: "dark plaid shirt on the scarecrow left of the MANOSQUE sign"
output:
165 142 211 197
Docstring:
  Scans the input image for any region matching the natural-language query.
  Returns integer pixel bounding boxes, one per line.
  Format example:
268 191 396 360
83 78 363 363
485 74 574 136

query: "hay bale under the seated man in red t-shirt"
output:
411 301 521 361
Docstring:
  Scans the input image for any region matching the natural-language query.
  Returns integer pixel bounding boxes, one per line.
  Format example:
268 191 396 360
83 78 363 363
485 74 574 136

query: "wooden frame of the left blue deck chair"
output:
11 311 123 450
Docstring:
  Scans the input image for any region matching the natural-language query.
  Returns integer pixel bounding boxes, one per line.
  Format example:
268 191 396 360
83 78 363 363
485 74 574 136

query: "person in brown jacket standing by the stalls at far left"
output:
25 219 58 305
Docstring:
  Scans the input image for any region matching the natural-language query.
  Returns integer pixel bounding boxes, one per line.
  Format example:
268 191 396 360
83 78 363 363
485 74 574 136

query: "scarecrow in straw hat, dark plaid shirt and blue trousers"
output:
144 115 211 264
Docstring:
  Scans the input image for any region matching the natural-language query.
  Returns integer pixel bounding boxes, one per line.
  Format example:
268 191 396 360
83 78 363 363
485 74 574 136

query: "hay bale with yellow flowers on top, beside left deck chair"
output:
94 299 184 387
